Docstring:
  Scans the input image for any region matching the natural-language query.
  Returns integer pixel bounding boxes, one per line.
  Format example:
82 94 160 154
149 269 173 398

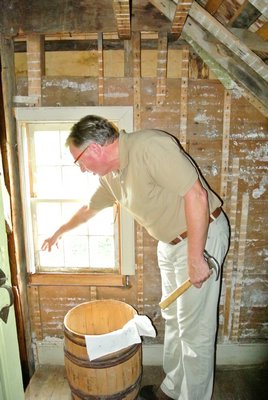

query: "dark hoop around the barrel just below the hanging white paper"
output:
64 343 141 369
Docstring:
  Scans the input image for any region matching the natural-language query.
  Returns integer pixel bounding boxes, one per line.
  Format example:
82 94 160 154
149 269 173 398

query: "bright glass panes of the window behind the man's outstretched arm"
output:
28 123 118 271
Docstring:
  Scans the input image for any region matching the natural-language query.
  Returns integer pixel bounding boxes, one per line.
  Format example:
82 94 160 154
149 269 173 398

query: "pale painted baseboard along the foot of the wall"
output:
35 338 268 365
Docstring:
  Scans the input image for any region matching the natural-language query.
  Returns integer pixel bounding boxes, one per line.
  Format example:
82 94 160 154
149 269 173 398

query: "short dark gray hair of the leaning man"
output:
66 115 119 147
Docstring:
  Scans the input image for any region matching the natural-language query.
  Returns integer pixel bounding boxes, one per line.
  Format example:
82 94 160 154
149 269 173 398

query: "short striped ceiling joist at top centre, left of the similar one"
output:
113 0 131 39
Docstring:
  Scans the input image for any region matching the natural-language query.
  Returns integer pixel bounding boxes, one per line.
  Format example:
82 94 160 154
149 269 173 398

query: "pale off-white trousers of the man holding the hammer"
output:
157 212 229 400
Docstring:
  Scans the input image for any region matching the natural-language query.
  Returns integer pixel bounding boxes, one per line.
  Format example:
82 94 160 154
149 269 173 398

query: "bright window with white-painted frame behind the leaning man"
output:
16 107 135 282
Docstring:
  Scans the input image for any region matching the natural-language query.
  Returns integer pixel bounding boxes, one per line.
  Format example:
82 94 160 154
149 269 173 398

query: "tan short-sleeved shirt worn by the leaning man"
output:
90 130 221 242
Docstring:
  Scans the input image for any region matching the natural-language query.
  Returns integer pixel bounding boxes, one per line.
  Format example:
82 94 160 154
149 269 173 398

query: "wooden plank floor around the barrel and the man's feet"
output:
25 365 268 400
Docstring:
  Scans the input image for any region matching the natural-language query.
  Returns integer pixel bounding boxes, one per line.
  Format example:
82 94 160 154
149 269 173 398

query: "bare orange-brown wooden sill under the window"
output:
28 272 126 287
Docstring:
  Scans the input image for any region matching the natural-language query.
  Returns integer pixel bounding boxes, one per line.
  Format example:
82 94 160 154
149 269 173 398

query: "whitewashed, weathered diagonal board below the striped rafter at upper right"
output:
182 17 268 116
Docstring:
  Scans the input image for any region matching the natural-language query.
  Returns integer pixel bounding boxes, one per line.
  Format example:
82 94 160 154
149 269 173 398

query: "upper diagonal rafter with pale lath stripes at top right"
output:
189 2 268 82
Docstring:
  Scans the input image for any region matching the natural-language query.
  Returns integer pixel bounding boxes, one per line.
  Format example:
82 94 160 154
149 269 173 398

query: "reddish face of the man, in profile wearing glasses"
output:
69 143 109 176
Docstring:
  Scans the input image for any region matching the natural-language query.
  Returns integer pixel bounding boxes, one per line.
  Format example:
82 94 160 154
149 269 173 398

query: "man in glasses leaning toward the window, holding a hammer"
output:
42 115 229 400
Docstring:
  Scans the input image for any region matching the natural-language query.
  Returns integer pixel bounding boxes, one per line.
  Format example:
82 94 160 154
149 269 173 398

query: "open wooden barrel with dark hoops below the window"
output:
64 300 142 400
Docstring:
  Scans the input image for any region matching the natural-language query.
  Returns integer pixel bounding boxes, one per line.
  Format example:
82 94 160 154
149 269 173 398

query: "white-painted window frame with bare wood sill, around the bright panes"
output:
14 106 135 286
